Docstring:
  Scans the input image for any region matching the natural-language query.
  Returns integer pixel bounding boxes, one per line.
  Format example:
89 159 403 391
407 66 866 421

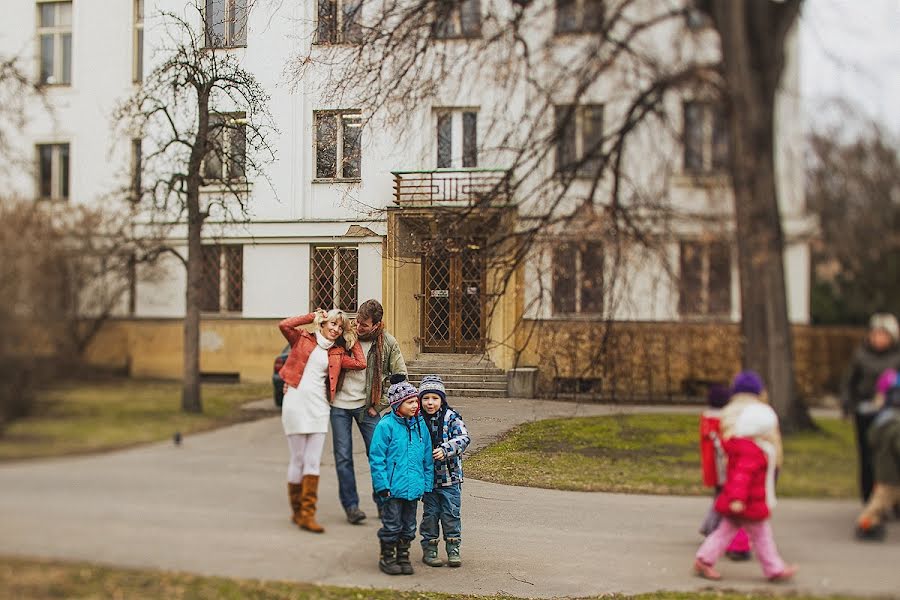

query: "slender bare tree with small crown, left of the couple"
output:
117 4 274 412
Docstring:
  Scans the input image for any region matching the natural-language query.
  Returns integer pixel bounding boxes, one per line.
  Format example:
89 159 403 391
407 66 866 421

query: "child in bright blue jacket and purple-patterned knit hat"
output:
369 374 434 575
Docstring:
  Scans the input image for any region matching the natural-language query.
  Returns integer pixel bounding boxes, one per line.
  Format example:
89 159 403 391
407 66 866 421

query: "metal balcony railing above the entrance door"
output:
392 169 511 207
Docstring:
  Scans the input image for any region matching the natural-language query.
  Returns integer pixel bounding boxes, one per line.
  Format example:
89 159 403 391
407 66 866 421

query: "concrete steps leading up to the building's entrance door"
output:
406 354 506 399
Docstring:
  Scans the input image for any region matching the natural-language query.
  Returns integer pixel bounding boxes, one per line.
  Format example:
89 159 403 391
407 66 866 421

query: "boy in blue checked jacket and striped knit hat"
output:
419 375 470 567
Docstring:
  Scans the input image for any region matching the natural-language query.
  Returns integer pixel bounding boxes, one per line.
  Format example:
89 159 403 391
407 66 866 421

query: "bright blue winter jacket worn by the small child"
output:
369 411 434 500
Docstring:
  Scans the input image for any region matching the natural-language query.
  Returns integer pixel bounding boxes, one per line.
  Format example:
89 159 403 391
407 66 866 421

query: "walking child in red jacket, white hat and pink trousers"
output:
694 403 797 581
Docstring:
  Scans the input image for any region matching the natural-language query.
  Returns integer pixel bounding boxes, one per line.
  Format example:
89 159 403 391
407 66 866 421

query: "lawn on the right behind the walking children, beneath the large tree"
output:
465 414 856 498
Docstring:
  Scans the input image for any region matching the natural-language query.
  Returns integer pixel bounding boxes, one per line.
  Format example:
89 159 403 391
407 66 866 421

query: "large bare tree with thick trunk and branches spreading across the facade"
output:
293 0 810 430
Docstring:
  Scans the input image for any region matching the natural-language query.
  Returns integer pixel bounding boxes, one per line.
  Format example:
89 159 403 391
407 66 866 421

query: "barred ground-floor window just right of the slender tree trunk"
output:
200 245 244 313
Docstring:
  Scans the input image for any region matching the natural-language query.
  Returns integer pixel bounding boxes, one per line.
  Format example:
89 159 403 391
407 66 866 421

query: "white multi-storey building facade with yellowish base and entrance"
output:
0 0 811 394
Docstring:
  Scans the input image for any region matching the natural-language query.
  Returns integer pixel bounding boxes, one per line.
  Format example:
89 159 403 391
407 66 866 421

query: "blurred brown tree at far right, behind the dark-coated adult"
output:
807 115 900 324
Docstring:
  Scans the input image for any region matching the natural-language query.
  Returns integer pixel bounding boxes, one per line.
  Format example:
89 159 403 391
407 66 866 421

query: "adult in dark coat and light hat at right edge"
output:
841 313 900 503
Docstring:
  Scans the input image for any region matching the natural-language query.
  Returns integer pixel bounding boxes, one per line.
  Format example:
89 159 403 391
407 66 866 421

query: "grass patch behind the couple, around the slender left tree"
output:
0 379 272 461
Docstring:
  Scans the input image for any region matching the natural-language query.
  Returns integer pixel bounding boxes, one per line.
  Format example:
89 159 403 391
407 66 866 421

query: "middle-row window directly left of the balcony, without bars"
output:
315 111 362 179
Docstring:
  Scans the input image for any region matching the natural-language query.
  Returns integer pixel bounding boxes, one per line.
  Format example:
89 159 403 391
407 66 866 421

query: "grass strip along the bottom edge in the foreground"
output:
0 557 880 600
